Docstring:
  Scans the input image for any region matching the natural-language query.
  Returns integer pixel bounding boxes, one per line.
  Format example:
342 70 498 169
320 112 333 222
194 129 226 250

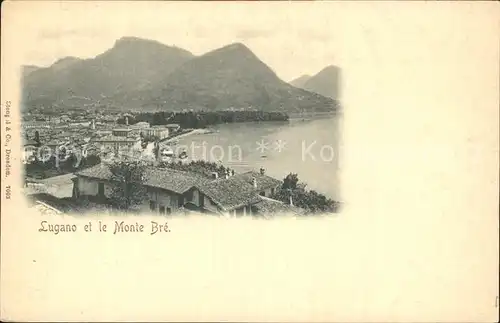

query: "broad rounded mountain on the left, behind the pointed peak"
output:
23 37 193 104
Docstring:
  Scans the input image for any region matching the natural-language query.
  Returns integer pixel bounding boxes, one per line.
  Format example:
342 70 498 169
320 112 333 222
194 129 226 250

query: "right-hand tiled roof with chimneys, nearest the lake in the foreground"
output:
198 171 281 211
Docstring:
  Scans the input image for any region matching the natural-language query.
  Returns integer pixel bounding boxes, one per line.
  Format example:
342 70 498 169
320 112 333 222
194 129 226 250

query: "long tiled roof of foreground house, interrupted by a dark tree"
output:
76 163 208 194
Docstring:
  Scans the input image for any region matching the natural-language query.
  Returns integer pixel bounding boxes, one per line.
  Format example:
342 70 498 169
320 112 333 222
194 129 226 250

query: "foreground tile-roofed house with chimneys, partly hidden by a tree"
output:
73 164 302 216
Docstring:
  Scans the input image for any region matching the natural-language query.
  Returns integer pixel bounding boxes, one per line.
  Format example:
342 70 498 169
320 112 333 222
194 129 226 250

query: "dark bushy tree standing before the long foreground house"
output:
109 160 147 210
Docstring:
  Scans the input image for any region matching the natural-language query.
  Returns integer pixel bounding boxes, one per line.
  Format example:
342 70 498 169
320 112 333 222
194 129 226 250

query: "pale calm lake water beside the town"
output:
177 116 341 200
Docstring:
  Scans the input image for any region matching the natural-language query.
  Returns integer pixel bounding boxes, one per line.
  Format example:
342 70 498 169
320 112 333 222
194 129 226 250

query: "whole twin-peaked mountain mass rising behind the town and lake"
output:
23 37 337 111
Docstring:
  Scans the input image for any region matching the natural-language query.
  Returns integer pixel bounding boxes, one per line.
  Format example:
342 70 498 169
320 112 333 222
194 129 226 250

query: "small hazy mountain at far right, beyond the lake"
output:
290 65 341 100
